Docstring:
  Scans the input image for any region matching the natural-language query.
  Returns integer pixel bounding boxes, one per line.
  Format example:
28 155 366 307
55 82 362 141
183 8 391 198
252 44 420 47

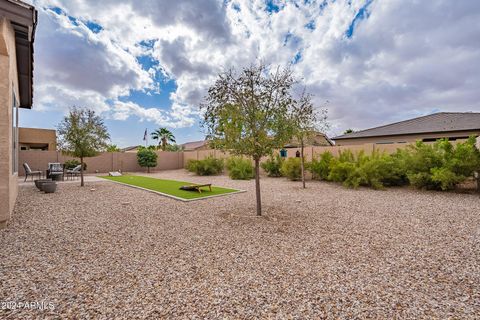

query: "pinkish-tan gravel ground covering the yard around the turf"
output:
0 170 480 319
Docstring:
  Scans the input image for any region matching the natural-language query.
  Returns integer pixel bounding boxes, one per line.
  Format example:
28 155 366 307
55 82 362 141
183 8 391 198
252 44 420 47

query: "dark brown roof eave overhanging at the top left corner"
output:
0 0 38 109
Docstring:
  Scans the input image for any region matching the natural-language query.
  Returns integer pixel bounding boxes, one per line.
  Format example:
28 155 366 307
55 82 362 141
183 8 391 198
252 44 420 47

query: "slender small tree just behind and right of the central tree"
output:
290 90 328 188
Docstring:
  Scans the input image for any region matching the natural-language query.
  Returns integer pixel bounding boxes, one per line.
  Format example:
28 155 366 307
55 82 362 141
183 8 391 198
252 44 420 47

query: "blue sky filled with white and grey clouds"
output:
20 0 480 147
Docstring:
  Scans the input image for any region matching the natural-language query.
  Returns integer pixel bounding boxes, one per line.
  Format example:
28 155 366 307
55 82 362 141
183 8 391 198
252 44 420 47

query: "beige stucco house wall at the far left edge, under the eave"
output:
0 18 19 228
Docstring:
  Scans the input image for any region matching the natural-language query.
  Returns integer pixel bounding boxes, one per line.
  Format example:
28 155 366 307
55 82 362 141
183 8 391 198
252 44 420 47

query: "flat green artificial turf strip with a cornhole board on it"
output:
102 175 239 200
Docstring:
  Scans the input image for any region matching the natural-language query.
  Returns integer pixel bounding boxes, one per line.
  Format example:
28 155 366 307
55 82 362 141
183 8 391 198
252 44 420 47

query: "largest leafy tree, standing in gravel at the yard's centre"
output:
201 64 295 215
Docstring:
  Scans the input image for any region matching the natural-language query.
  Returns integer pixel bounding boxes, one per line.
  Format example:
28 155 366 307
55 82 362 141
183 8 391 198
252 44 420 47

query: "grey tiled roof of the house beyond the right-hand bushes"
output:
332 112 480 140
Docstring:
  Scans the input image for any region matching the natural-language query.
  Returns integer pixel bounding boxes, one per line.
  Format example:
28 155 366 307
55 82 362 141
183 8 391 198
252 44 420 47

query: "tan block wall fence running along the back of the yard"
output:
19 142 455 175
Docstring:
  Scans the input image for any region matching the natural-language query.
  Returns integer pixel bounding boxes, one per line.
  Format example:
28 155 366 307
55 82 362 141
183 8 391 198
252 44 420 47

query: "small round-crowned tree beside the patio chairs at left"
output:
57 107 110 187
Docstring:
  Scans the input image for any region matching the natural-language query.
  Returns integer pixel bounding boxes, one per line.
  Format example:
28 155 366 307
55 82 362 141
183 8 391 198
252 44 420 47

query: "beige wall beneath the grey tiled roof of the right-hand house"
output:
335 130 480 146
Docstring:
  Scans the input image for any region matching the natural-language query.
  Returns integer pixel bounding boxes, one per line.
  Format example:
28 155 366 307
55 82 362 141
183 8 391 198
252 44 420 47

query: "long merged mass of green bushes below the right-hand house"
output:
326 137 480 190
